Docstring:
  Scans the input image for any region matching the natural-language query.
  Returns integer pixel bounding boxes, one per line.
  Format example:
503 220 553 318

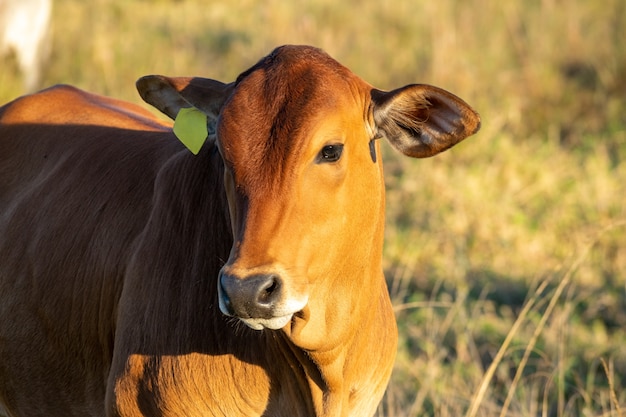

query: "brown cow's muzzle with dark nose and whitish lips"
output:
218 269 308 330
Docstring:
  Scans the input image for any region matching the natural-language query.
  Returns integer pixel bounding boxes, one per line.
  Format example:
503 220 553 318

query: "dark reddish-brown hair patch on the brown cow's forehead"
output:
219 46 348 192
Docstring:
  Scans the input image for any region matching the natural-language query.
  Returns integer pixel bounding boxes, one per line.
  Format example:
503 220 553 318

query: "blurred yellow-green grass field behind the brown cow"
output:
0 0 626 417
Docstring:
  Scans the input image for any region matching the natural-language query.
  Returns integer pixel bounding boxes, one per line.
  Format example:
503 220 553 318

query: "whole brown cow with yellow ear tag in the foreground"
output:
0 45 480 417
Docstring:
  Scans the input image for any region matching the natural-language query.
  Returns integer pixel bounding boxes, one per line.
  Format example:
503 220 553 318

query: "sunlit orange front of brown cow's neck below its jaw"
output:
283 268 397 416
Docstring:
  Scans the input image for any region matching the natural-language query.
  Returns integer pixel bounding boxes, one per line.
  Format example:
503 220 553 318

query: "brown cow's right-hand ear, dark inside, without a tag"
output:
371 85 480 158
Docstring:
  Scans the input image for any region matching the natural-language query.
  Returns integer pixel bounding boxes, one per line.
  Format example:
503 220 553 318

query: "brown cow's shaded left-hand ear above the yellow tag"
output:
137 75 234 122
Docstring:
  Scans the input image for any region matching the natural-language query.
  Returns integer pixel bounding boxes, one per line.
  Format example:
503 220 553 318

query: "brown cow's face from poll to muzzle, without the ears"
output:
217 48 383 329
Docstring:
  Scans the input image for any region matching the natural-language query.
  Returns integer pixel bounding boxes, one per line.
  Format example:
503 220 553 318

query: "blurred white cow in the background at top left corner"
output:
0 0 52 92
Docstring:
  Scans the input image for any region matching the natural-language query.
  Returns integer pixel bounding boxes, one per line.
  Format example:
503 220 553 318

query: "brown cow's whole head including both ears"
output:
138 46 480 344
